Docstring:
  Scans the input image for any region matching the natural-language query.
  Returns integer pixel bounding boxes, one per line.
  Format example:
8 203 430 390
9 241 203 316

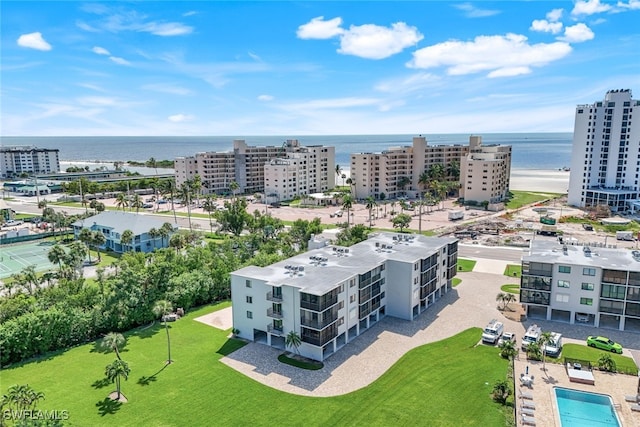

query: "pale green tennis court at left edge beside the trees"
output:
0 241 55 279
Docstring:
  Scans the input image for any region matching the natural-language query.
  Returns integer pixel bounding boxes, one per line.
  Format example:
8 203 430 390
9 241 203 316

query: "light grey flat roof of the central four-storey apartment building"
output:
232 233 458 295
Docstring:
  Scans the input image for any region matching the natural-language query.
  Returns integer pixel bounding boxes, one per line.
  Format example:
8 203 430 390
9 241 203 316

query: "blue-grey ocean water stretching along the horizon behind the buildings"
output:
0 133 573 170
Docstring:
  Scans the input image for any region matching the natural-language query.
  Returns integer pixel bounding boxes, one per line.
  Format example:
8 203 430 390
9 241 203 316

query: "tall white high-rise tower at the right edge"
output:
568 89 640 212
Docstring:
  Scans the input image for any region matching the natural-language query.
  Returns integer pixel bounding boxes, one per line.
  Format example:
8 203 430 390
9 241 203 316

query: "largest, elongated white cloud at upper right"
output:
407 34 571 77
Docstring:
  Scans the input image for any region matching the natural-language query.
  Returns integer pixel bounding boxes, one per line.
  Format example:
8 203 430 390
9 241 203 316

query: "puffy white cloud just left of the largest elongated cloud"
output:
338 22 424 59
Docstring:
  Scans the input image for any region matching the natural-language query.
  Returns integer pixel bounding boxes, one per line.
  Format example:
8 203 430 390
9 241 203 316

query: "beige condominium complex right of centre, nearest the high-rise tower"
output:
351 136 511 202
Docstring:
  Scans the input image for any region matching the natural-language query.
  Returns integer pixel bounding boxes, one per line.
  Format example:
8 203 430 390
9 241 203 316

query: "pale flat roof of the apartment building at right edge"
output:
522 240 640 271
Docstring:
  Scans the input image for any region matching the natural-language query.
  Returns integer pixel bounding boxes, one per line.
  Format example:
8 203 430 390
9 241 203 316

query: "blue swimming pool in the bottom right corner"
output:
554 387 622 427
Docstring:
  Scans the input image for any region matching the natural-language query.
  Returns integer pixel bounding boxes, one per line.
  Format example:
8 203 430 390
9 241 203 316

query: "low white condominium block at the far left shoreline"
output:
0 146 60 178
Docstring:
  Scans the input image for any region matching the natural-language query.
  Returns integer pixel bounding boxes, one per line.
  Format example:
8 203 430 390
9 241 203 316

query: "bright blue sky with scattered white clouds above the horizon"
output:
0 0 640 136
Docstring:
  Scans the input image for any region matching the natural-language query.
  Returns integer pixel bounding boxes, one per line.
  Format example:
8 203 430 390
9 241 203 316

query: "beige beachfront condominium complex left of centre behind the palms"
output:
175 139 335 196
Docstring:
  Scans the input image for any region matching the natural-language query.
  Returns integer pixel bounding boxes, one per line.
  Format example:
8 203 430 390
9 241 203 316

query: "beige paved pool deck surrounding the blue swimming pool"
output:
514 355 640 427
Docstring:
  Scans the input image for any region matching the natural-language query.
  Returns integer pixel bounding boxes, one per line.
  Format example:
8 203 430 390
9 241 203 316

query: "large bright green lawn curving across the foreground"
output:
0 303 510 426
